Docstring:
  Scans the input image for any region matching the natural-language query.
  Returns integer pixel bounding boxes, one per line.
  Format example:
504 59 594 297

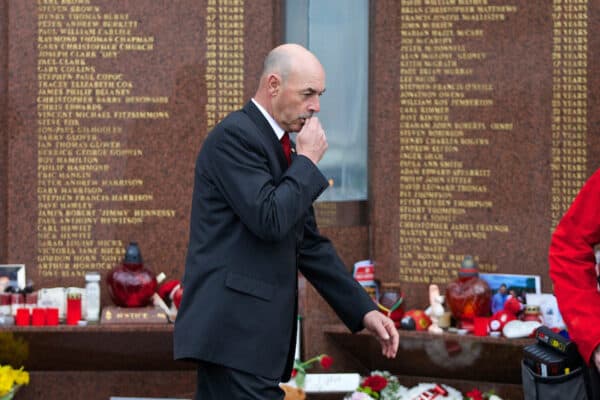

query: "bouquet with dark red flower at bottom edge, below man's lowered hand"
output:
344 371 407 400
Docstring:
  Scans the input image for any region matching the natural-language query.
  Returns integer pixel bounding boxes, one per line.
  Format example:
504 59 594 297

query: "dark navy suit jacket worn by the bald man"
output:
174 102 375 381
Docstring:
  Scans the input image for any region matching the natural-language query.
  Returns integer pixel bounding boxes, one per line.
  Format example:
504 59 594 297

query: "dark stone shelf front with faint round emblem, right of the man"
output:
323 324 534 399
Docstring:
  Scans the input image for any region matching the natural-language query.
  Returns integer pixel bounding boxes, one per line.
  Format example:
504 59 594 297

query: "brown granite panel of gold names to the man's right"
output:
371 0 600 306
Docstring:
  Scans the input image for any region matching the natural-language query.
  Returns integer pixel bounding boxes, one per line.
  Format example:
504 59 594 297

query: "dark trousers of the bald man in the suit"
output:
195 361 285 400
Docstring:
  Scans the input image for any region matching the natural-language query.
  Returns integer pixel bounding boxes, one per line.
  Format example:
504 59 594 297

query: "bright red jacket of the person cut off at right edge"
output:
549 169 600 363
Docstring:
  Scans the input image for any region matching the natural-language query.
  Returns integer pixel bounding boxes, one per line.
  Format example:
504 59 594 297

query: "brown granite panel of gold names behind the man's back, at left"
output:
0 0 277 297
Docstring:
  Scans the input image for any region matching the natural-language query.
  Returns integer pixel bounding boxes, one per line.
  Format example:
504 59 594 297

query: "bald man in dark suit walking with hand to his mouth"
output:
174 44 398 400
